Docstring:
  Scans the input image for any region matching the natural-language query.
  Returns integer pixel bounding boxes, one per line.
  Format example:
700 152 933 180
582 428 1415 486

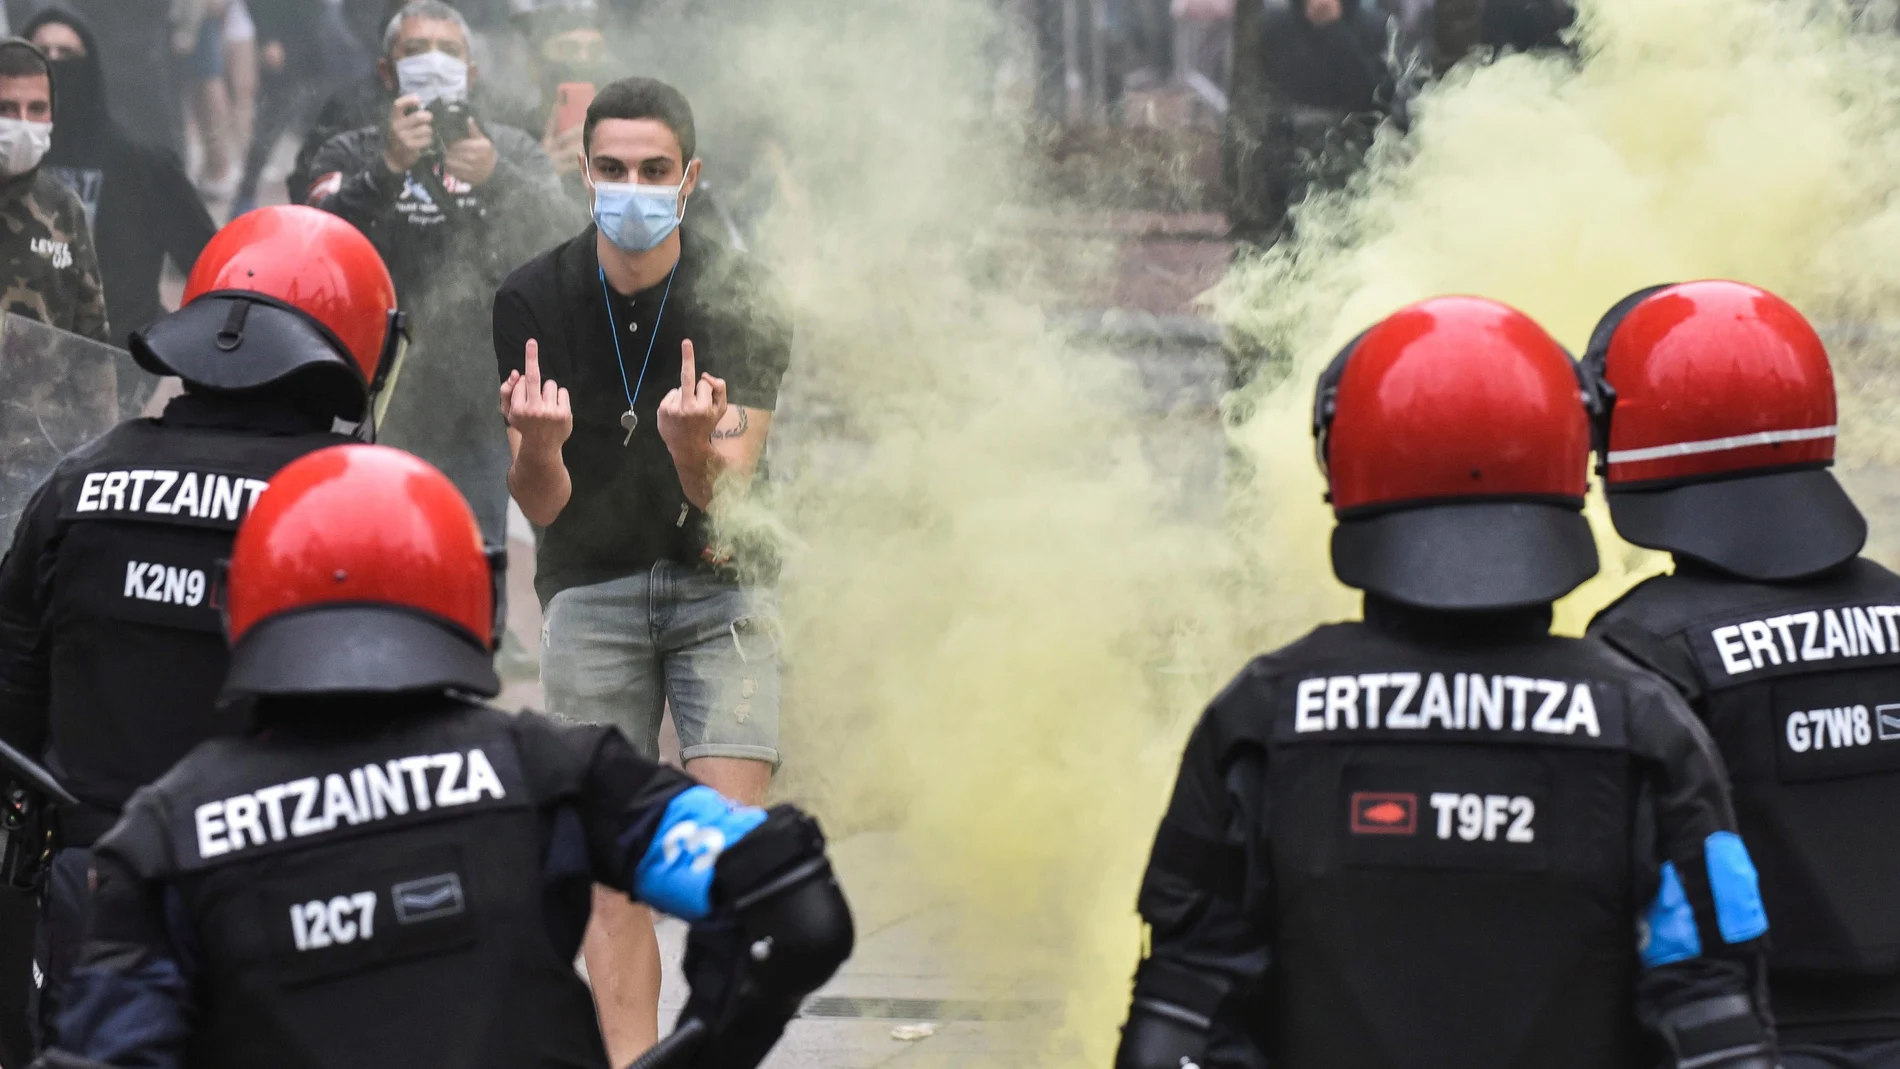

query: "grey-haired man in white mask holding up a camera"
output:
310 0 581 545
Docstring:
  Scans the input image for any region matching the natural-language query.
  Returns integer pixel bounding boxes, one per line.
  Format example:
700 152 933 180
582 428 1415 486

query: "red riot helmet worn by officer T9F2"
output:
1313 296 1596 610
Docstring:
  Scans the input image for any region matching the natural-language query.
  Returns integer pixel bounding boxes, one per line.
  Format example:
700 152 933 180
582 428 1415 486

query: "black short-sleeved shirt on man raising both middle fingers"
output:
494 226 792 604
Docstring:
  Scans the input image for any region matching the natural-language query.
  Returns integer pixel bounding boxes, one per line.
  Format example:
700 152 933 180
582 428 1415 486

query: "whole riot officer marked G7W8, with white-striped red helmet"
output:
1585 281 1900 1069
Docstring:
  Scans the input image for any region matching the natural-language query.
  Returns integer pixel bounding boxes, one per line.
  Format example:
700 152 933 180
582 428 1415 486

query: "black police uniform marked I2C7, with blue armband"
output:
49 695 851 1069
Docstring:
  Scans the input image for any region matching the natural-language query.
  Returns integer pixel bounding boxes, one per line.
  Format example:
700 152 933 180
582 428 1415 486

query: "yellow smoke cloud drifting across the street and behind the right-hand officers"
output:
646 0 1900 1065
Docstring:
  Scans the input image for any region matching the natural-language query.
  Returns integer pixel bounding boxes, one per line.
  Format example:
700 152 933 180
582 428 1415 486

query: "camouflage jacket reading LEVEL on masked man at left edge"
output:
0 171 112 344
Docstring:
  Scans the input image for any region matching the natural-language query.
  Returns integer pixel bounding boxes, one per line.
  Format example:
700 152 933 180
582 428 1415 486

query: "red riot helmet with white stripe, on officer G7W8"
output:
1585 281 1868 581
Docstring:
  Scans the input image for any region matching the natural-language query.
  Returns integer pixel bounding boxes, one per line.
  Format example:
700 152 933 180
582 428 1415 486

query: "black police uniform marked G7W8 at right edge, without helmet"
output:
1590 556 1900 1065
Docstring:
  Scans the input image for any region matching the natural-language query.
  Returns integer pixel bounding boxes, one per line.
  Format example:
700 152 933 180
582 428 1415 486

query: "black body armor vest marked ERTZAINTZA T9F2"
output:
1238 625 1638 1069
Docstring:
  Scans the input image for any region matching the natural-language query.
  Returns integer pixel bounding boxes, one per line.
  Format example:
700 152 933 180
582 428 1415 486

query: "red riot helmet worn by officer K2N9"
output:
131 205 403 420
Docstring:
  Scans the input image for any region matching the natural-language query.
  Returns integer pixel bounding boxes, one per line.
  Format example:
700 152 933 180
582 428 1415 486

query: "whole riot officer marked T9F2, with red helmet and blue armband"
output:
1117 298 1773 1069
